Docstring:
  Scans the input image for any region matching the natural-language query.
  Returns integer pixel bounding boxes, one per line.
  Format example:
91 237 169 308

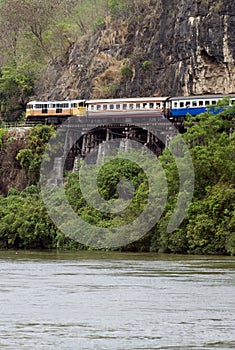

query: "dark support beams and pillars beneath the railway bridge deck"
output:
51 121 176 182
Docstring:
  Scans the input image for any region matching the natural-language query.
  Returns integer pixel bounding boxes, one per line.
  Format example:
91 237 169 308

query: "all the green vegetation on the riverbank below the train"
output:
0 104 235 254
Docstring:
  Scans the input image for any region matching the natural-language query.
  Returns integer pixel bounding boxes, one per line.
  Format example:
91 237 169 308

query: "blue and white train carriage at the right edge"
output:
169 95 235 122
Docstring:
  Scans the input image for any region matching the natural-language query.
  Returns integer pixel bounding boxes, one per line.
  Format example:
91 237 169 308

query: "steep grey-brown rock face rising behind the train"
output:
36 0 235 99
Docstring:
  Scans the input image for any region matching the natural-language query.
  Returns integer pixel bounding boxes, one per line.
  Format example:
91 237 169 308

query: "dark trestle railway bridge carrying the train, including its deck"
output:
1 111 177 182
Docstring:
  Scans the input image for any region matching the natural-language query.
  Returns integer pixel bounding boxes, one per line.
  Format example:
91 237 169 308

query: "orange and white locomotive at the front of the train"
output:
26 100 86 125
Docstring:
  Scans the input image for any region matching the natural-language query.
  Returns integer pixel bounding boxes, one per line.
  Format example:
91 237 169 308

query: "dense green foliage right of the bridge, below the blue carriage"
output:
151 104 235 254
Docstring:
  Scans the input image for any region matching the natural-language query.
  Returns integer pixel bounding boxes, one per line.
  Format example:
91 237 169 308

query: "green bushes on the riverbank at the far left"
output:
0 186 83 249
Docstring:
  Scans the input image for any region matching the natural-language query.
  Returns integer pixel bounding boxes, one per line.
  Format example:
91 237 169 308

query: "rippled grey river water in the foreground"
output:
0 252 235 350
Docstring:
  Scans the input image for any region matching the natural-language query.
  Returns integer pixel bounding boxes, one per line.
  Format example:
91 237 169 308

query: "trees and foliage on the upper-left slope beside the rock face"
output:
0 0 109 117
